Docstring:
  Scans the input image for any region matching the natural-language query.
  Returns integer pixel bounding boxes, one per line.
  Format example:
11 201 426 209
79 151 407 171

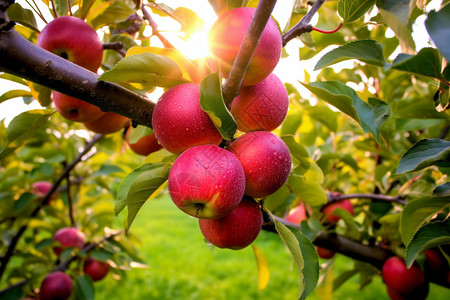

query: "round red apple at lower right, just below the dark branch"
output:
381 256 425 295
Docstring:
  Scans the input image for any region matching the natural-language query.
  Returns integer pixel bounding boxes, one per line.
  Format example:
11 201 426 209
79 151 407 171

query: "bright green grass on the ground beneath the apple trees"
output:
95 197 450 300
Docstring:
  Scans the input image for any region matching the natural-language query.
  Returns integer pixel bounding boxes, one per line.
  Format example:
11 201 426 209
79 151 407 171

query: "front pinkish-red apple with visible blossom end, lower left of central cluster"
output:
169 145 245 219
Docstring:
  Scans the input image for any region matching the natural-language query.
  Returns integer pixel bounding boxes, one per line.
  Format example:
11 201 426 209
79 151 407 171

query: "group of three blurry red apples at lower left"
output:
38 227 109 300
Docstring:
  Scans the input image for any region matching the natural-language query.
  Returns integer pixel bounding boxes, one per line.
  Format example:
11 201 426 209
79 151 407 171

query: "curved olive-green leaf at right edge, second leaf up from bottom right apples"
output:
400 196 450 246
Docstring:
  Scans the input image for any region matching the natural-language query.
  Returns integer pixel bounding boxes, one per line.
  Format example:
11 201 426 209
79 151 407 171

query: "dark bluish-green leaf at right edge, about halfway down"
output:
396 139 450 174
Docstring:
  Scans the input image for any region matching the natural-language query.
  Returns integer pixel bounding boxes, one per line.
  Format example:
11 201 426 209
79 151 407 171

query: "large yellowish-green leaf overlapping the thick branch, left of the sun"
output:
98 53 187 89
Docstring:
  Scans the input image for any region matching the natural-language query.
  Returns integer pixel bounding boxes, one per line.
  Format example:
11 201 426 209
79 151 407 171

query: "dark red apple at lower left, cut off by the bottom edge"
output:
39 271 73 300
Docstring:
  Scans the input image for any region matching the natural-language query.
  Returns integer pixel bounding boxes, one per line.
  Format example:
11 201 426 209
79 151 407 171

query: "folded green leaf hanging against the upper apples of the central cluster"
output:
200 73 237 140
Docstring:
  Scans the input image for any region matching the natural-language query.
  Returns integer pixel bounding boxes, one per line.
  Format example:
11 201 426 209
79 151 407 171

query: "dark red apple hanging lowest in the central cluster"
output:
198 197 263 250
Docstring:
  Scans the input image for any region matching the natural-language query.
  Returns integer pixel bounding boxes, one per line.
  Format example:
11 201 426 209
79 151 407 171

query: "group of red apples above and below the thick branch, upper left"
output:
37 16 130 134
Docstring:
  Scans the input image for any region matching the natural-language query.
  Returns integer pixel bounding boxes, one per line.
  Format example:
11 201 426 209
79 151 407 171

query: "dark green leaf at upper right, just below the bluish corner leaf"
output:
389 48 443 79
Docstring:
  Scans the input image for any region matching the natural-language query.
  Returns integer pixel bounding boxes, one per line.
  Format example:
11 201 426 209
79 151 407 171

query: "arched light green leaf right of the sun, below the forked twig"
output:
314 39 386 70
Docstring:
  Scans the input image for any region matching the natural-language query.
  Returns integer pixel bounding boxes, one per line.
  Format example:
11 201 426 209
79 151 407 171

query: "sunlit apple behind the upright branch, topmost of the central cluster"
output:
208 7 282 85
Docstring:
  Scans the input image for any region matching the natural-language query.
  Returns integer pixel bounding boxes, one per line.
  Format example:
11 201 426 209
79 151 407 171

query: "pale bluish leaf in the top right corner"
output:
425 5 450 61
